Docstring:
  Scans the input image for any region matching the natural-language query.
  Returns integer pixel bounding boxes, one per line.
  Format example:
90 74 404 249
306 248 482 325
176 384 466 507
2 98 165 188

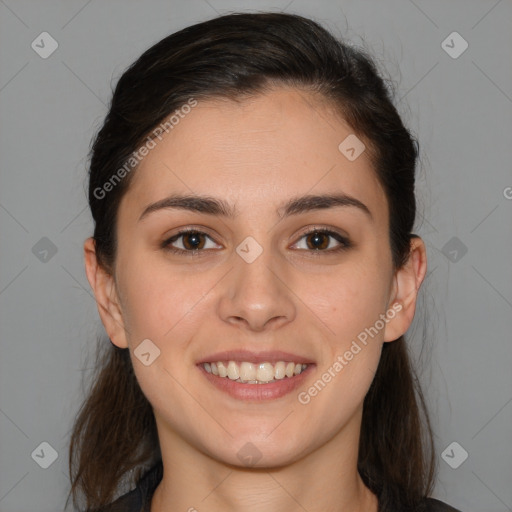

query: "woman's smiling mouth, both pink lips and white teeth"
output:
197 351 315 401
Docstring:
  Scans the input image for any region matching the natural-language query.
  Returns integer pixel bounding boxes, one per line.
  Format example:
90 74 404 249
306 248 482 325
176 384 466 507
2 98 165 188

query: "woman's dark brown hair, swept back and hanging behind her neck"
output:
68 13 435 511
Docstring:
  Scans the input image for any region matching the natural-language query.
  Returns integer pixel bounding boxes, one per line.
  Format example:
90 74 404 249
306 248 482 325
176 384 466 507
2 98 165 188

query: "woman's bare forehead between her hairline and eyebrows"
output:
121 88 386 223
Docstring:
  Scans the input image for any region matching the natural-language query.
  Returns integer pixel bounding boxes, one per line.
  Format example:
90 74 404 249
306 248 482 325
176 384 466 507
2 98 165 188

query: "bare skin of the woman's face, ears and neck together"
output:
84 88 426 512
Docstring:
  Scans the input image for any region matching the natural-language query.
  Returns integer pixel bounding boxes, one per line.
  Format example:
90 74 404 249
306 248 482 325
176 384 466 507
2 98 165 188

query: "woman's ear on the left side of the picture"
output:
84 237 128 348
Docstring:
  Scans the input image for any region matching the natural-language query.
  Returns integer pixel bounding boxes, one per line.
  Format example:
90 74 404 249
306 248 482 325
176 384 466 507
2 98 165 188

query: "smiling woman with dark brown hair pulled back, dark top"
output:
66 13 462 512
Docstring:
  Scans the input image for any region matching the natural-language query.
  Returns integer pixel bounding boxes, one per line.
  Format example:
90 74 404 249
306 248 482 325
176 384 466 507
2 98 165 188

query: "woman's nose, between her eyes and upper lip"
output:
218 243 296 331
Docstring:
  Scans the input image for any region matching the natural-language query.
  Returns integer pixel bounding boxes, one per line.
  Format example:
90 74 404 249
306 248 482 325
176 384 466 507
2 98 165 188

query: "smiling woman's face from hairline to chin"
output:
88 88 416 466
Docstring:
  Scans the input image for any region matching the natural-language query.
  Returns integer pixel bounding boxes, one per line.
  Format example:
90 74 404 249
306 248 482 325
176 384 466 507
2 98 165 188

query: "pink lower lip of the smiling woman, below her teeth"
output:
197 364 315 402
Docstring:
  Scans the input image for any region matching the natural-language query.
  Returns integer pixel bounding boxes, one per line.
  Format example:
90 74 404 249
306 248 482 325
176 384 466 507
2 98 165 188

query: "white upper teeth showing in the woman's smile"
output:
203 361 308 382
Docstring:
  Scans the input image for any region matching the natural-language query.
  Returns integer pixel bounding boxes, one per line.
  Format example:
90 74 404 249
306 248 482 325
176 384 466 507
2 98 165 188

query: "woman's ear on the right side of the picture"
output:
384 235 427 341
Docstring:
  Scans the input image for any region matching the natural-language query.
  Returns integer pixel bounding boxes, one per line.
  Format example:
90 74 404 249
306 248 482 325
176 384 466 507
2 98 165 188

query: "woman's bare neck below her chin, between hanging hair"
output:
151 421 378 512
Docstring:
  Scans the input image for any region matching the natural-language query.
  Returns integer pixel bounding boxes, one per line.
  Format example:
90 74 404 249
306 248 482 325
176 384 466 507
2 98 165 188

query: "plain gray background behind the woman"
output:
0 0 512 512
